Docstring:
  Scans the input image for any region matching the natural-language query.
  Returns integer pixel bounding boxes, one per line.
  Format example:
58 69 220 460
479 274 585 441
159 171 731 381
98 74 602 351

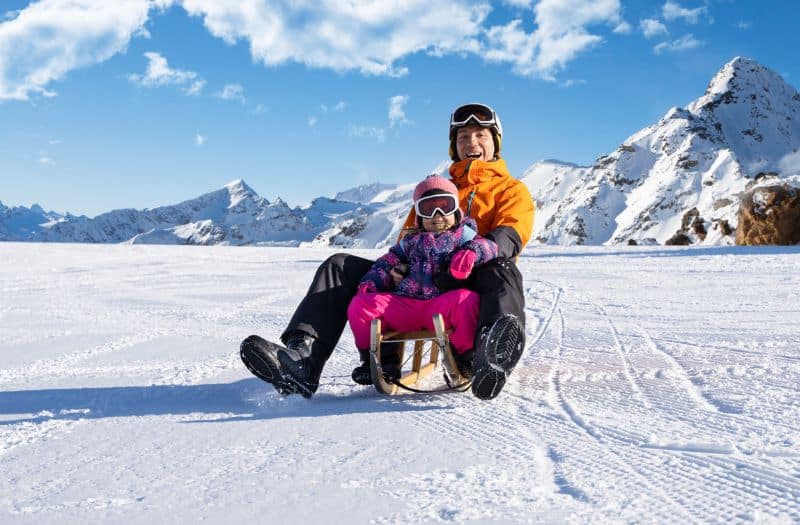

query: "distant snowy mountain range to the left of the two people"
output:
0 180 422 247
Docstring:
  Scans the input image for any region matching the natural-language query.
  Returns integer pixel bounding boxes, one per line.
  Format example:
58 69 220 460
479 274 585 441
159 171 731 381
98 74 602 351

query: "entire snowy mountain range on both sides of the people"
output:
0 57 800 248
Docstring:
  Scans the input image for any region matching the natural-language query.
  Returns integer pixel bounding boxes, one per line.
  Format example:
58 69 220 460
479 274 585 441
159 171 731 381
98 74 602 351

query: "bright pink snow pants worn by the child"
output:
347 289 480 354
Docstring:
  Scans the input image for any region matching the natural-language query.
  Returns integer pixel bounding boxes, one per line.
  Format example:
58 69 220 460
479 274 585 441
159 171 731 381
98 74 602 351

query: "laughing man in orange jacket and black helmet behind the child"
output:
241 104 534 399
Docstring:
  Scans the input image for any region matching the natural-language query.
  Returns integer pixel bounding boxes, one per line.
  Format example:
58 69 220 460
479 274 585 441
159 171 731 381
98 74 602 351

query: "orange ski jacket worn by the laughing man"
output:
404 159 535 258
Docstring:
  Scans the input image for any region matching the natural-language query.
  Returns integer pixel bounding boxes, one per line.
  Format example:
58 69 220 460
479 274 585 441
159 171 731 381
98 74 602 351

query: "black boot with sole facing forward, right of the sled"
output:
472 314 525 399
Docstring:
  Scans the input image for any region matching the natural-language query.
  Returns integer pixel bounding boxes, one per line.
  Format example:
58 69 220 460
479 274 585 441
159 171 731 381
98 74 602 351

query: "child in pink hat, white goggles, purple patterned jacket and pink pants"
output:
347 175 497 385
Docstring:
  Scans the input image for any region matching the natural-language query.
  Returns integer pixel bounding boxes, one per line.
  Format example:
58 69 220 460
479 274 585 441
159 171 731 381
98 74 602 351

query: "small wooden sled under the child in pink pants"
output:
369 314 470 395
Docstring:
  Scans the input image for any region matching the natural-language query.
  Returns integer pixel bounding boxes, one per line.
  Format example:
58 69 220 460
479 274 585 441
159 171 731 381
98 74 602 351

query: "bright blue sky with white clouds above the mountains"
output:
0 0 800 216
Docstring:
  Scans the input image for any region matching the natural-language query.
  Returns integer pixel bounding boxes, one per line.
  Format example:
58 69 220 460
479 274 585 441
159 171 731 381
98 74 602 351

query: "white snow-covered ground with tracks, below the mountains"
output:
0 243 800 524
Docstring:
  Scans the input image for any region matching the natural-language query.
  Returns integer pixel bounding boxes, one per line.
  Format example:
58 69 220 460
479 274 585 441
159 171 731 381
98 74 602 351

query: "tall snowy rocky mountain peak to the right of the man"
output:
524 57 800 244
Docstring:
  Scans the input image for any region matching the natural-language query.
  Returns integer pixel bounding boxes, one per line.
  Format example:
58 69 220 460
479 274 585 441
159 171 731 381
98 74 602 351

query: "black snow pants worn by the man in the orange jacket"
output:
281 253 525 364
